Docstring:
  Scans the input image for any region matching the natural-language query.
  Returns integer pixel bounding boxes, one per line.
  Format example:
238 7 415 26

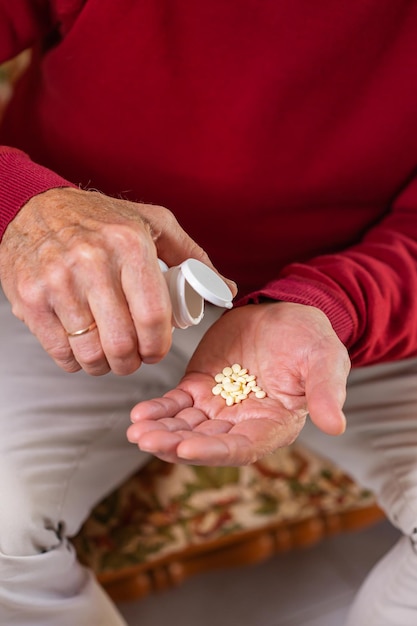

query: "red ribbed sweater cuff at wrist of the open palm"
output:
236 277 355 348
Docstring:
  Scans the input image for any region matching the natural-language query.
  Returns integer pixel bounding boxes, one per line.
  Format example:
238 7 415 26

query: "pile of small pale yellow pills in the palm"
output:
211 363 266 406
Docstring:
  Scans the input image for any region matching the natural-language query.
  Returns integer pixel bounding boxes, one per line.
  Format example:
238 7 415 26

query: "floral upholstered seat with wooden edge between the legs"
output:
74 445 382 599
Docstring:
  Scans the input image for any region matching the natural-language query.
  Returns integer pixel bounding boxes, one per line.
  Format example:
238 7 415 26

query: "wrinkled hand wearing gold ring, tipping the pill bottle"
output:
0 188 234 375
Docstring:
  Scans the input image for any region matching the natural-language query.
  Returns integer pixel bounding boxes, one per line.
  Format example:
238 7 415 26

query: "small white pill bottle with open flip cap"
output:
158 259 233 329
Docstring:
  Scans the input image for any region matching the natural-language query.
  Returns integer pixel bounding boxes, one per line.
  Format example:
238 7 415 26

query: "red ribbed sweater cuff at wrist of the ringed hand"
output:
0 147 77 241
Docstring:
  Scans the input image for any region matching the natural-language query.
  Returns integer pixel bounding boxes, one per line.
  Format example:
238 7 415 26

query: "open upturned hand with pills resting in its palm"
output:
128 302 350 465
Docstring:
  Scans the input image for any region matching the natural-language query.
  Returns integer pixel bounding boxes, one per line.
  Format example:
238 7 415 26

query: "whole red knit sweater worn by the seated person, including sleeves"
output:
0 0 417 365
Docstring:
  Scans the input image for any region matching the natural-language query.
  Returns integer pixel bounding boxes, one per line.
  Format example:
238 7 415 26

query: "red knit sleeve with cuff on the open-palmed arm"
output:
239 177 417 366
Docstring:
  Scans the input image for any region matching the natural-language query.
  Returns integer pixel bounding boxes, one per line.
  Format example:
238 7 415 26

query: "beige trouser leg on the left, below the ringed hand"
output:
0 290 211 626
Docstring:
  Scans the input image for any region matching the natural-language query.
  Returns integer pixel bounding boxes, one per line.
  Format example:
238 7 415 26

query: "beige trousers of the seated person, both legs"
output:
0 284 417 626
